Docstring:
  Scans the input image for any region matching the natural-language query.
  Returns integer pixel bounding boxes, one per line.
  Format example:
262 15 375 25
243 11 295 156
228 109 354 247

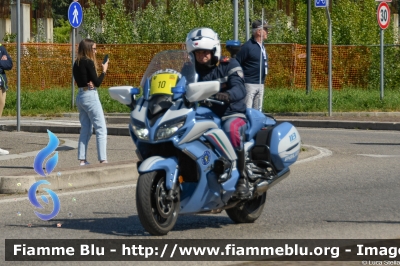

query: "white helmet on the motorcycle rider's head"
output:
186 28 221 61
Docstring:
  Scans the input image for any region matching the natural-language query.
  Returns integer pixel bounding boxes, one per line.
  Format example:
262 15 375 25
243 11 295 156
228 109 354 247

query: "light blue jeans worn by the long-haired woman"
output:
76 90 107 161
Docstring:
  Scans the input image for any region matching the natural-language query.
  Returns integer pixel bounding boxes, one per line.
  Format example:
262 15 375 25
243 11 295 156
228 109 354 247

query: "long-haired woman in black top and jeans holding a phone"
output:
73 39 109 166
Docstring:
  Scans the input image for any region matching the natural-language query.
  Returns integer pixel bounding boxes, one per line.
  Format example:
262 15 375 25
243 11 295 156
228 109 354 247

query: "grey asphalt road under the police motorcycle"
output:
0 128 400 265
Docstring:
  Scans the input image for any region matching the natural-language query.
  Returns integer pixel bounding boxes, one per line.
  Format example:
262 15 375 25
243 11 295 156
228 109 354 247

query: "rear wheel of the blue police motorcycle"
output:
225 192 267 223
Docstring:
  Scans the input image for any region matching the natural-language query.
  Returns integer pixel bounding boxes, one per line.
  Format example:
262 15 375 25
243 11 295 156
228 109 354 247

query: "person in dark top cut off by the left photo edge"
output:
0 43 13 155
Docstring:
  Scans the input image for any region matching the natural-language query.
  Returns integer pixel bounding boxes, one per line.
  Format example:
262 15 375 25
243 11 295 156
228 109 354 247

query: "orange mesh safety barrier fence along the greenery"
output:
4 43 371 90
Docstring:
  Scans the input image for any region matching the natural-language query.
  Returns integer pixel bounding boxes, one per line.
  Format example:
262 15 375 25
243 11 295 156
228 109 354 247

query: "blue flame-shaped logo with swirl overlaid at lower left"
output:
28 130 60 221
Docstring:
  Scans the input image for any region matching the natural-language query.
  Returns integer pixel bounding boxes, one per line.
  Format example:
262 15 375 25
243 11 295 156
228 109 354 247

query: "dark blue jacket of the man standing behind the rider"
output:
236 38 268 84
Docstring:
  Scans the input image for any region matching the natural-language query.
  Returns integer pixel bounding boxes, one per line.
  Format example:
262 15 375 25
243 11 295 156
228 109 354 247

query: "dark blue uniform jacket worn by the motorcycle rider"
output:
196 58 246 117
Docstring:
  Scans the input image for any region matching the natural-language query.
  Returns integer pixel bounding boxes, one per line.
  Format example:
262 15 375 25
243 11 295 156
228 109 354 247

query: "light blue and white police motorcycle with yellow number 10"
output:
109 50 301 235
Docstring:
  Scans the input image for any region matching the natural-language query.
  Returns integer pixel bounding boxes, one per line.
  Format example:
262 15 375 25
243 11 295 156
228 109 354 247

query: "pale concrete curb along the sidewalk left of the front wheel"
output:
0 160 138 194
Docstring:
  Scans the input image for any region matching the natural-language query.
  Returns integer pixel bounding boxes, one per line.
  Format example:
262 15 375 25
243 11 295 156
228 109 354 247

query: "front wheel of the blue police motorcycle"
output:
136 171 180 236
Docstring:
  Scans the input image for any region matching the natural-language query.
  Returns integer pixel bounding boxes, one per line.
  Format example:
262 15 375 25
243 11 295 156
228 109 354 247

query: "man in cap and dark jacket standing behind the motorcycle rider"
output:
236 20 270 111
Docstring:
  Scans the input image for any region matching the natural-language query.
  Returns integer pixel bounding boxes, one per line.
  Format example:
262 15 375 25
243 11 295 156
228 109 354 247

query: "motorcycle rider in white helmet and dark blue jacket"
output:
186 28 250 198
